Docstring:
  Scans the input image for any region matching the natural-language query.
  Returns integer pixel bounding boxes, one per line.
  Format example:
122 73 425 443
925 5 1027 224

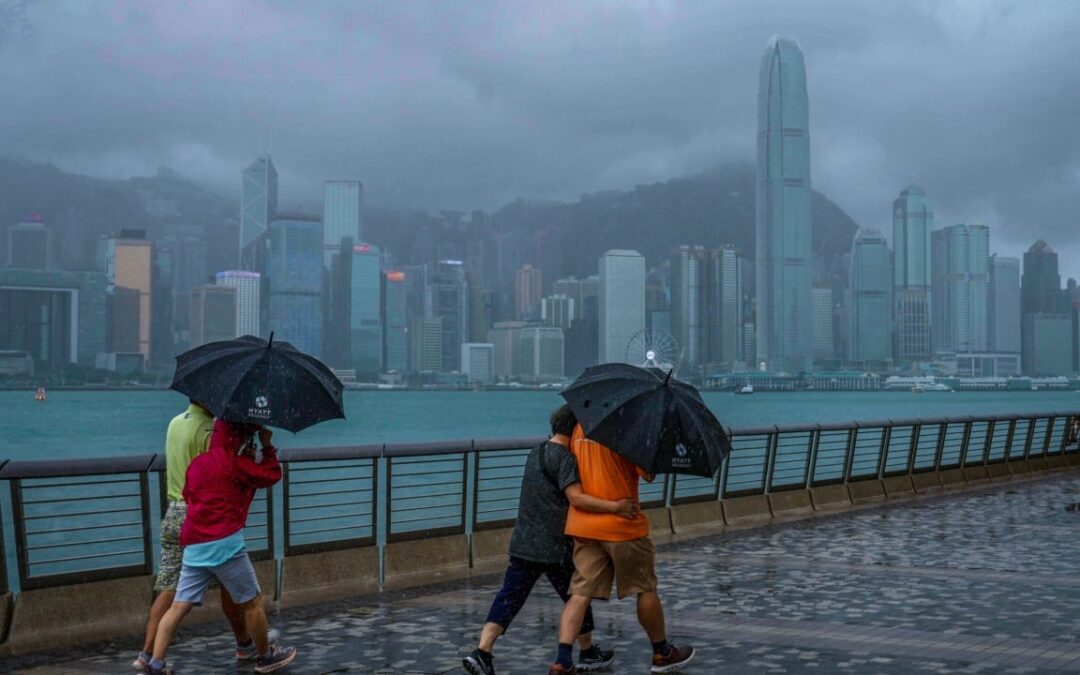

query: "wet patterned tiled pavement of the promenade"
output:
8 474 1080 675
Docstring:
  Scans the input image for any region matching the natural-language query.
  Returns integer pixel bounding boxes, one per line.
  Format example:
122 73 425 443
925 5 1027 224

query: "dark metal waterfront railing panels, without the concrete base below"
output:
0 413 1080 590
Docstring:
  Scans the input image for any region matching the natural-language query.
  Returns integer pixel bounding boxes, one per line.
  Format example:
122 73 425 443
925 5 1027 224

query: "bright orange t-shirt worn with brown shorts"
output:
566 424 649 541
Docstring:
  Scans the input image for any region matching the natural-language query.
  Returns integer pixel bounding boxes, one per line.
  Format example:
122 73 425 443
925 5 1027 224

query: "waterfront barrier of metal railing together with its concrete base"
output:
0 413 1080 653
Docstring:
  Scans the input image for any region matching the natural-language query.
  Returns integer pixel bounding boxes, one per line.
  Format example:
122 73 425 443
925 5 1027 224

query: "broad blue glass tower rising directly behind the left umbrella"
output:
267 216 323 356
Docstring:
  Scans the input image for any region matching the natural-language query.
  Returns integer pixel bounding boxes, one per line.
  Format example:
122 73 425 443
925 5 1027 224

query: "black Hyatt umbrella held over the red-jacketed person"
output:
170 334 345 432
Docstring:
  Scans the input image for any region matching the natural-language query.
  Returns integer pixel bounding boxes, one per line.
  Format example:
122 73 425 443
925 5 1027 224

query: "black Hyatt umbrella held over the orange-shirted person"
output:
563 363 731 477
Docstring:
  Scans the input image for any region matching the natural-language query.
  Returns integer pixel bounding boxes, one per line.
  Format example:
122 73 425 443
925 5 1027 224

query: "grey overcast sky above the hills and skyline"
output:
0 0 1080 275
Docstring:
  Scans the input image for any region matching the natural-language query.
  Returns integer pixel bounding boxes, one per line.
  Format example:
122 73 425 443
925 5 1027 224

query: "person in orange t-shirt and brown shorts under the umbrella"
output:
548 424 694 675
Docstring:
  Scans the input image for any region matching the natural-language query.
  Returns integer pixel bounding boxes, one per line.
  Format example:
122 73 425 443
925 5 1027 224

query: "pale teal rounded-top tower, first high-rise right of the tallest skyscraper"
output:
849 228 893 363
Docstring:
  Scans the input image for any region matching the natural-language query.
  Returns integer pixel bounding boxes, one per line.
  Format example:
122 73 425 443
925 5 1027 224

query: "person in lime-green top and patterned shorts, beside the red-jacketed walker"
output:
132 399 256 671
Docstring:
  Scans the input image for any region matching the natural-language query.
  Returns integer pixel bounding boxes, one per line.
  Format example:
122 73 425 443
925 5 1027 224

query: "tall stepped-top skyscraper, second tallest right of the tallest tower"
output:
892 185 934 363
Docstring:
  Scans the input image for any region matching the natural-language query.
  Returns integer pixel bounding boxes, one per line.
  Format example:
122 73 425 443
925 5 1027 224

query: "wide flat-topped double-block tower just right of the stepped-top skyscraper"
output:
931 225 990 352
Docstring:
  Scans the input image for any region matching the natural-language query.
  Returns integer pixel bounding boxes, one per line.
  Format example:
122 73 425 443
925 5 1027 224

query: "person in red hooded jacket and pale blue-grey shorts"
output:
148 419 296 675
